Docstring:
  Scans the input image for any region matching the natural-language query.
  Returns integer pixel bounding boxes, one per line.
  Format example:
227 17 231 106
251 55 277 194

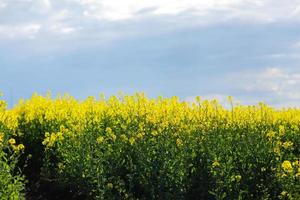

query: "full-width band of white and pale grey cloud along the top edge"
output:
0 0 299 39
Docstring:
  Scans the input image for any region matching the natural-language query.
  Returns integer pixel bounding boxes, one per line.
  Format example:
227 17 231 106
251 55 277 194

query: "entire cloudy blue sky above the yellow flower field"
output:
0 0 300 107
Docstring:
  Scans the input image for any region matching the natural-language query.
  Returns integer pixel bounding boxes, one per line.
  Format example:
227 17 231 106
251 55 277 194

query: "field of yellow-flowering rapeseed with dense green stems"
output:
0 94 300 200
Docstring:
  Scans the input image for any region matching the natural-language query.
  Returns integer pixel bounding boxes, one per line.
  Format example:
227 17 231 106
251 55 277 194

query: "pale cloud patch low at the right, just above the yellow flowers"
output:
230 67 300 107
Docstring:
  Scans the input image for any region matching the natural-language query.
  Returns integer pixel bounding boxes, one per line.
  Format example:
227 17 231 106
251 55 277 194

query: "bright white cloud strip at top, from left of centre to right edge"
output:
68 0 298 22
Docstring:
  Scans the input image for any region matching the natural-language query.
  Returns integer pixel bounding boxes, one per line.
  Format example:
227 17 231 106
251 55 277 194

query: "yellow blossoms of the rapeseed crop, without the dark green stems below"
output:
0 93 300 196
